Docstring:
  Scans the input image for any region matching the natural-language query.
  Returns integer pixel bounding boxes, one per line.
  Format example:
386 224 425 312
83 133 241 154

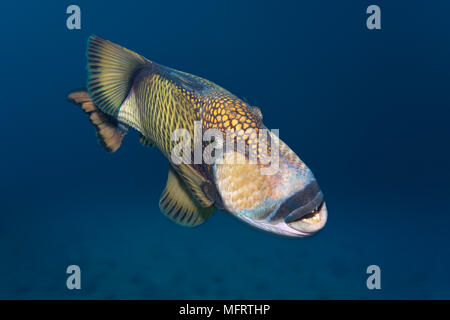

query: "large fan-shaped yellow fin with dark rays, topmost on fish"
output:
87 36 149 117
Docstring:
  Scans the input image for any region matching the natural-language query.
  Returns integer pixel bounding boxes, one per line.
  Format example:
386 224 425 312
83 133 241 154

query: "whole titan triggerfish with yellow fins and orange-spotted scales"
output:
67 35 328 237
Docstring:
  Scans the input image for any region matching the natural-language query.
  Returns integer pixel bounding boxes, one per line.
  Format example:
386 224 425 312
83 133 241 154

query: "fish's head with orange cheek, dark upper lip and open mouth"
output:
213 132 328 237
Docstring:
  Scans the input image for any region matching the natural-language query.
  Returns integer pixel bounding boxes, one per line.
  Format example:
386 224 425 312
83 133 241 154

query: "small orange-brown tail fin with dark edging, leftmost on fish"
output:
67 89 128 152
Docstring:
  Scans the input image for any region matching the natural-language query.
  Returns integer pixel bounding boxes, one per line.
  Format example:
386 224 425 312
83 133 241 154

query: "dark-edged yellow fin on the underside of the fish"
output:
159 167 216 227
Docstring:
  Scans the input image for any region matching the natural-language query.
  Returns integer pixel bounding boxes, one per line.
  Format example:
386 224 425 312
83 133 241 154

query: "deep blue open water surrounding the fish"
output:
0 0 450 299
